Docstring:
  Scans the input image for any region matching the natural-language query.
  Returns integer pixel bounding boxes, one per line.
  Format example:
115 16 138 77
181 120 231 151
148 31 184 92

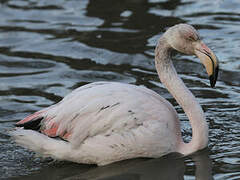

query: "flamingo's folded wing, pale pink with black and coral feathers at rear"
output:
16 82 176 149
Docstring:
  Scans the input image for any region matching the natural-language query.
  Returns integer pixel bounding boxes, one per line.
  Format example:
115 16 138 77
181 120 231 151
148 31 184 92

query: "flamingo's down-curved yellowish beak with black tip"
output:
195 41 219 88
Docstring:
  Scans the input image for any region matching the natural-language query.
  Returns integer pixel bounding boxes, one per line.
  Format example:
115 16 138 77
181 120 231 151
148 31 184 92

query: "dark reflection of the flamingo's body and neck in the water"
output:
65 149 213 180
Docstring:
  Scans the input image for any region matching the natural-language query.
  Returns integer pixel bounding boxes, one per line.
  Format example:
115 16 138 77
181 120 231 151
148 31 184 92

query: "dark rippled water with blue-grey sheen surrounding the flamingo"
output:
0 0 240 180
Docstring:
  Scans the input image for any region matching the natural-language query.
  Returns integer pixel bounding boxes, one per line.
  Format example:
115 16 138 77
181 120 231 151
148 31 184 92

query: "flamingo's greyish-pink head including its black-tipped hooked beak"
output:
164 24 219 87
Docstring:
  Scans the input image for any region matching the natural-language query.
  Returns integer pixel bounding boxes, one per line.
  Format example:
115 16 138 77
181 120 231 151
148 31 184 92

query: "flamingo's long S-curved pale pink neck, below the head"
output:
155 36 208 155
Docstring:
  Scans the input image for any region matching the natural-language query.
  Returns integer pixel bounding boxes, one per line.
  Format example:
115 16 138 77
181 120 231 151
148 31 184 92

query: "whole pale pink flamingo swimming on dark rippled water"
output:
11 24 218 166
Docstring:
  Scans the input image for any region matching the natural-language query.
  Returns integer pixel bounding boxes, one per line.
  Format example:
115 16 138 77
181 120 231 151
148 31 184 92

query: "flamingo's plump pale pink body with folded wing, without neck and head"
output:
15 82 181 165
